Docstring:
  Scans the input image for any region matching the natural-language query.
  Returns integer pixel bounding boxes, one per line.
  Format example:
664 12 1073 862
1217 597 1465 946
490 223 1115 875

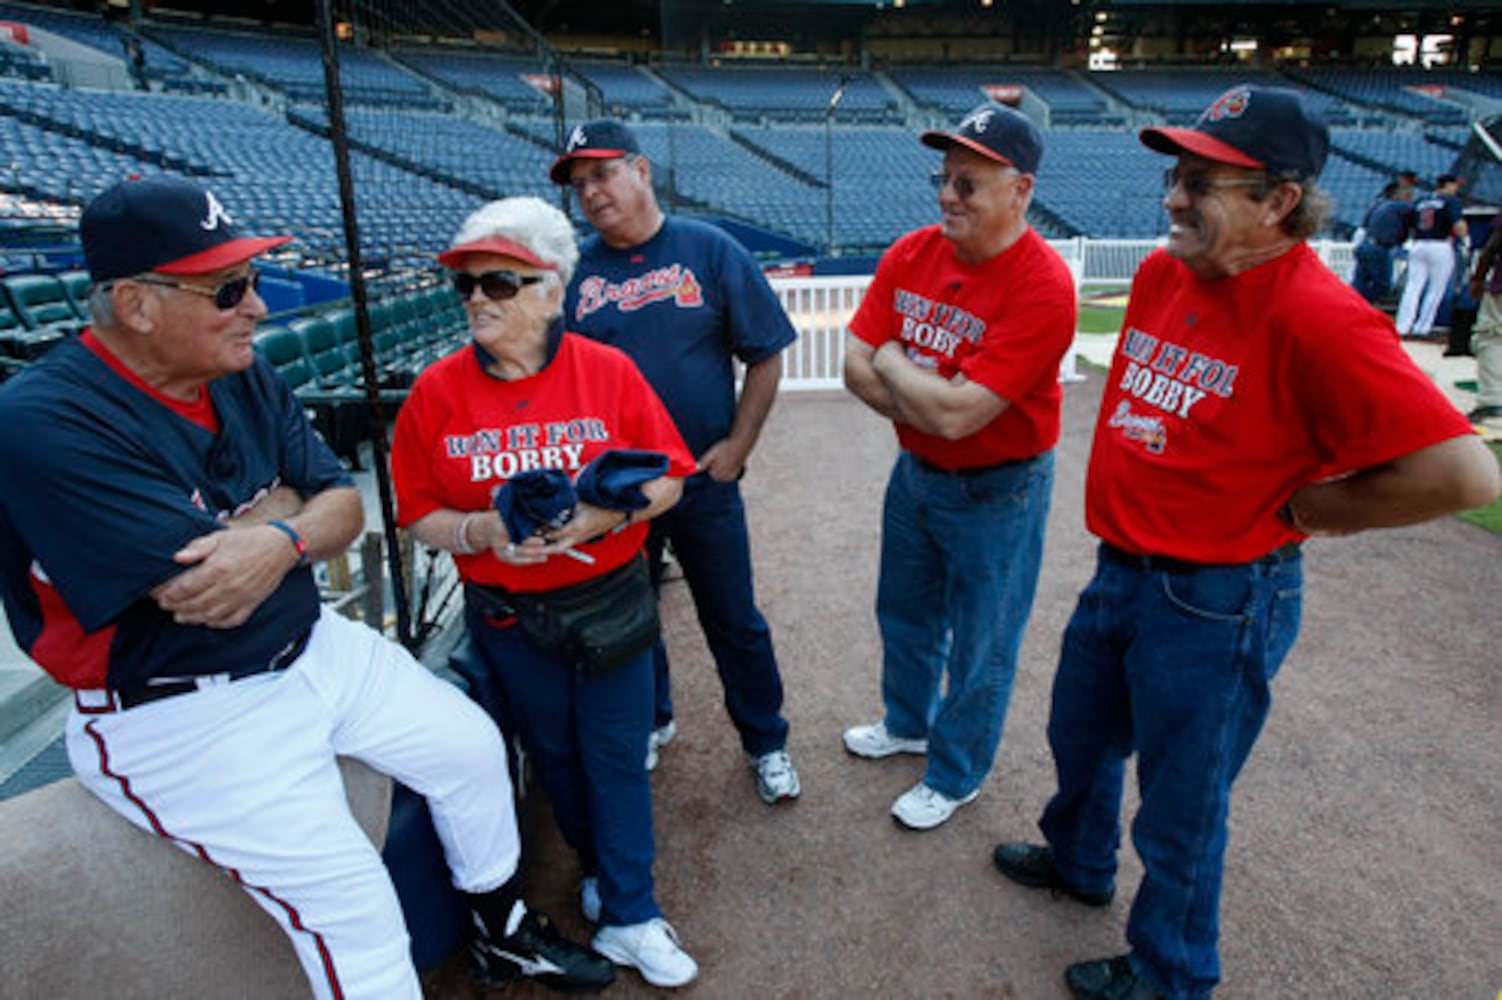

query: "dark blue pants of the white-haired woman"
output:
464 608 662 925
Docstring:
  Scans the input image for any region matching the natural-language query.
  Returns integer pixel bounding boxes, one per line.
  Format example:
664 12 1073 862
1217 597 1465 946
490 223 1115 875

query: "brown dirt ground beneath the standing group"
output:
425 372 1502 1000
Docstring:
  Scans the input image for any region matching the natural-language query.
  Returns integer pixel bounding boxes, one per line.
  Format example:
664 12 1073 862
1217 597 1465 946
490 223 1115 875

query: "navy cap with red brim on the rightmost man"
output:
1139 84 1329 180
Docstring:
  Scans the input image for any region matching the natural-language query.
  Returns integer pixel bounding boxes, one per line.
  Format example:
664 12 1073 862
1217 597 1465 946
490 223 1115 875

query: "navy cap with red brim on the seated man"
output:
78 177 291 284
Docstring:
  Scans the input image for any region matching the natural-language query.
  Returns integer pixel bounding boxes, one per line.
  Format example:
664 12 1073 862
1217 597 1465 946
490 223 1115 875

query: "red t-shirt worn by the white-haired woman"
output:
391 333 695 592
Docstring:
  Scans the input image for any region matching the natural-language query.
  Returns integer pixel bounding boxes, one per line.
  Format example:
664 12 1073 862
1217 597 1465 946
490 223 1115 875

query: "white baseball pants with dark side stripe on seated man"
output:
68 610 520 1000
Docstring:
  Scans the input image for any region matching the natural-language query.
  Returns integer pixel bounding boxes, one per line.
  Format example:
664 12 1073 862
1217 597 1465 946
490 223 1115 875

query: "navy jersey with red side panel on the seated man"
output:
0 330 351 691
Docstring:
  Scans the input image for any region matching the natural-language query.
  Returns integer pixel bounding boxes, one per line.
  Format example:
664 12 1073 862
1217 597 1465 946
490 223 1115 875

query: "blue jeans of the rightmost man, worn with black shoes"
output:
1039 547 1304 998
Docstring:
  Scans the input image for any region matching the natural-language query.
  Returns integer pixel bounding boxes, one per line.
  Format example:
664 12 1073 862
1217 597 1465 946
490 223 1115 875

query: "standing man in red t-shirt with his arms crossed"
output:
844 104 1075 830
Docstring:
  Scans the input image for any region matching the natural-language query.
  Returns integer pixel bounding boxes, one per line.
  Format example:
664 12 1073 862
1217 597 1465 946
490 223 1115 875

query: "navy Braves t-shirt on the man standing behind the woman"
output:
563 216 798 458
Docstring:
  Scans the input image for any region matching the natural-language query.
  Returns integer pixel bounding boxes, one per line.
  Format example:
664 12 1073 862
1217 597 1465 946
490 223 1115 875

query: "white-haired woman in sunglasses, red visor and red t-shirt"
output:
392 198 698 986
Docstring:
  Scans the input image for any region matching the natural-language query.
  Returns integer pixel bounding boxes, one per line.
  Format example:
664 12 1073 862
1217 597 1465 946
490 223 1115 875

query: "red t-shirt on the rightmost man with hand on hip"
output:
1084 243 1470 563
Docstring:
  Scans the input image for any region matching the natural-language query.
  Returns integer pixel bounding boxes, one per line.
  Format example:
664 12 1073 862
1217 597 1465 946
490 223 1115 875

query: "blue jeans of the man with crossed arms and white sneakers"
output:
876 452 1053 799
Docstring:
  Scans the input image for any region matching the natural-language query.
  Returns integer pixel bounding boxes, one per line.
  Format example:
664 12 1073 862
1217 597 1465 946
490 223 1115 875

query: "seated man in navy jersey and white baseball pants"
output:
0 177 613 998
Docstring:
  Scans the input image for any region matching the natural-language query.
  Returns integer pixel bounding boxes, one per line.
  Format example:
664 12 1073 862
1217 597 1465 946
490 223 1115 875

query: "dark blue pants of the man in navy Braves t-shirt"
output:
647 473 787 757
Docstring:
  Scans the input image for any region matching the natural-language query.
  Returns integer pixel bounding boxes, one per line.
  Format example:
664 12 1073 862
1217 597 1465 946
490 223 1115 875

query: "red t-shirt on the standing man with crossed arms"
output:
850 225 1075 468
